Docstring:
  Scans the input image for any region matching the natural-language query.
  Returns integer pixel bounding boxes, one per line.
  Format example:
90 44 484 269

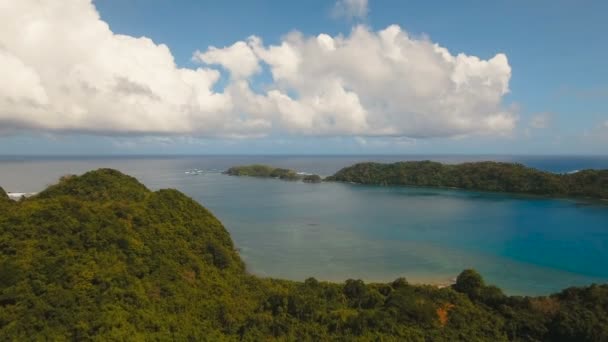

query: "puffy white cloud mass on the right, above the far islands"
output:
238 26 516 137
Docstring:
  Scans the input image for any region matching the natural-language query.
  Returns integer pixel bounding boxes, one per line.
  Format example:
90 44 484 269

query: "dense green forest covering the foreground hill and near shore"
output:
0 169 608 341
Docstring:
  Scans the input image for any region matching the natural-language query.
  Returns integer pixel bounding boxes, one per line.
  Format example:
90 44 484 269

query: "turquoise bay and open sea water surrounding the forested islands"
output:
0 156 608 294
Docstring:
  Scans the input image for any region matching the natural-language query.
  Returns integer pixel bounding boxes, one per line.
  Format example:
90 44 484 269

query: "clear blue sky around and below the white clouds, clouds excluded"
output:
0 0 608 154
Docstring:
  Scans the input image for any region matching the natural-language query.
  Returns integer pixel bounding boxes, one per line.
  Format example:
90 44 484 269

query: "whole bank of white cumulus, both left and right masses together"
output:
0 0 516 138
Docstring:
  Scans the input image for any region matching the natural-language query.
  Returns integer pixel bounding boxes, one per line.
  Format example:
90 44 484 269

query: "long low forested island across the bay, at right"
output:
327 161 608 199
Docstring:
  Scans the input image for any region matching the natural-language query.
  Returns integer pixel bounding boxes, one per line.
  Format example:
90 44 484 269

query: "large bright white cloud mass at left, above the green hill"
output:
0 0 250 134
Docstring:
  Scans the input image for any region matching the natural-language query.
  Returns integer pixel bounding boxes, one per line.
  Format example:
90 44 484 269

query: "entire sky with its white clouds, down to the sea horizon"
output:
0 0 608 155
